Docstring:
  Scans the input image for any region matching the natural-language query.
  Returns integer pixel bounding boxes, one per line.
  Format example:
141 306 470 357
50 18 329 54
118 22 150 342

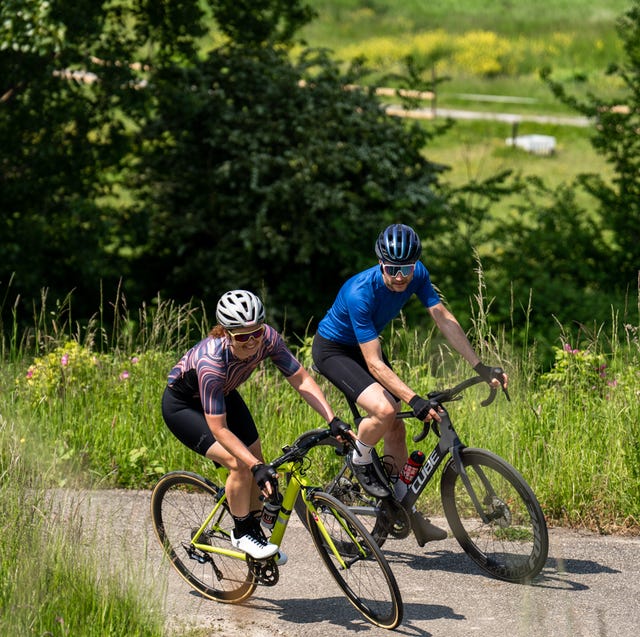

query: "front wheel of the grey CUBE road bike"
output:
440 448 549 583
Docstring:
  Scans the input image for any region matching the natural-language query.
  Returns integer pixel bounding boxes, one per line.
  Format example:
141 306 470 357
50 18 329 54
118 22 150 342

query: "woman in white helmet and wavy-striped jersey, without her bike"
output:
162 290 353 561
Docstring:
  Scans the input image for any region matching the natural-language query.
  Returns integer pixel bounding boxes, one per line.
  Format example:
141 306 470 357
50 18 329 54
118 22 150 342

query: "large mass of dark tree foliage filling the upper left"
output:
0 0 452 330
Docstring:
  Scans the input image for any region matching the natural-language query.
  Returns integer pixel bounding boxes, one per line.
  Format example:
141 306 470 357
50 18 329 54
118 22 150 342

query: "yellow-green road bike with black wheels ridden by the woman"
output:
151 428 403 629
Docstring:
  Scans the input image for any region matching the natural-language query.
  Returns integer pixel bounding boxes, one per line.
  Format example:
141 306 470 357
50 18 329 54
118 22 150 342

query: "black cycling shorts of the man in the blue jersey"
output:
311 334 398 402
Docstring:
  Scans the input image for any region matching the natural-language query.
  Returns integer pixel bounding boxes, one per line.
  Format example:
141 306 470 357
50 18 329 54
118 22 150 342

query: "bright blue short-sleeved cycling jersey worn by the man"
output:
318 261 440 345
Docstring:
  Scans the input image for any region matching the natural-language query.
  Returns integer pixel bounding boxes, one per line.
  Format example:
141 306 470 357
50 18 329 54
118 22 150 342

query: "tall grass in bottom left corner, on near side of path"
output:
0 412 164 637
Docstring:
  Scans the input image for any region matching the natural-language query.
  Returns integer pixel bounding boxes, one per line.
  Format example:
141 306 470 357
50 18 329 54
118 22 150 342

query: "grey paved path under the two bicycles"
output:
52 491 640 637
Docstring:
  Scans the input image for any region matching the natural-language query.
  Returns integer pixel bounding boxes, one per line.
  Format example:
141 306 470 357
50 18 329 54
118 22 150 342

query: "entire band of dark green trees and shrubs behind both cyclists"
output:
0 0 640 358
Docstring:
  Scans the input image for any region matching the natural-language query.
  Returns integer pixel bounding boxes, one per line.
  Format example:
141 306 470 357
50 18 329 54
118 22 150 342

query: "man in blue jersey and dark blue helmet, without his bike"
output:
312 224 508 541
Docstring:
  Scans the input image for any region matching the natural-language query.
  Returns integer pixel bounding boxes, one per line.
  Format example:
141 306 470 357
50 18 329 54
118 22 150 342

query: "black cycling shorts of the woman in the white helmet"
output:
162 387 258 456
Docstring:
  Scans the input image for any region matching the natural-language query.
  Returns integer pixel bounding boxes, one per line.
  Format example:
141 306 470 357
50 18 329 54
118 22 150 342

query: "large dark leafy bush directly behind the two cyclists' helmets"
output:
134 5 450 331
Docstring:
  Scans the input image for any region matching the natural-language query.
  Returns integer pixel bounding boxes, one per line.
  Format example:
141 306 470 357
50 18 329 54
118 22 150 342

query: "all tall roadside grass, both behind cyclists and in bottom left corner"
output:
0 286 640 637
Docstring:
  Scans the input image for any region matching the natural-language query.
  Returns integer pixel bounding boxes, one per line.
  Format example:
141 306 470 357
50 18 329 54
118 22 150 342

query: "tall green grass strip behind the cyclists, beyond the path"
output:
0 282 640 531
